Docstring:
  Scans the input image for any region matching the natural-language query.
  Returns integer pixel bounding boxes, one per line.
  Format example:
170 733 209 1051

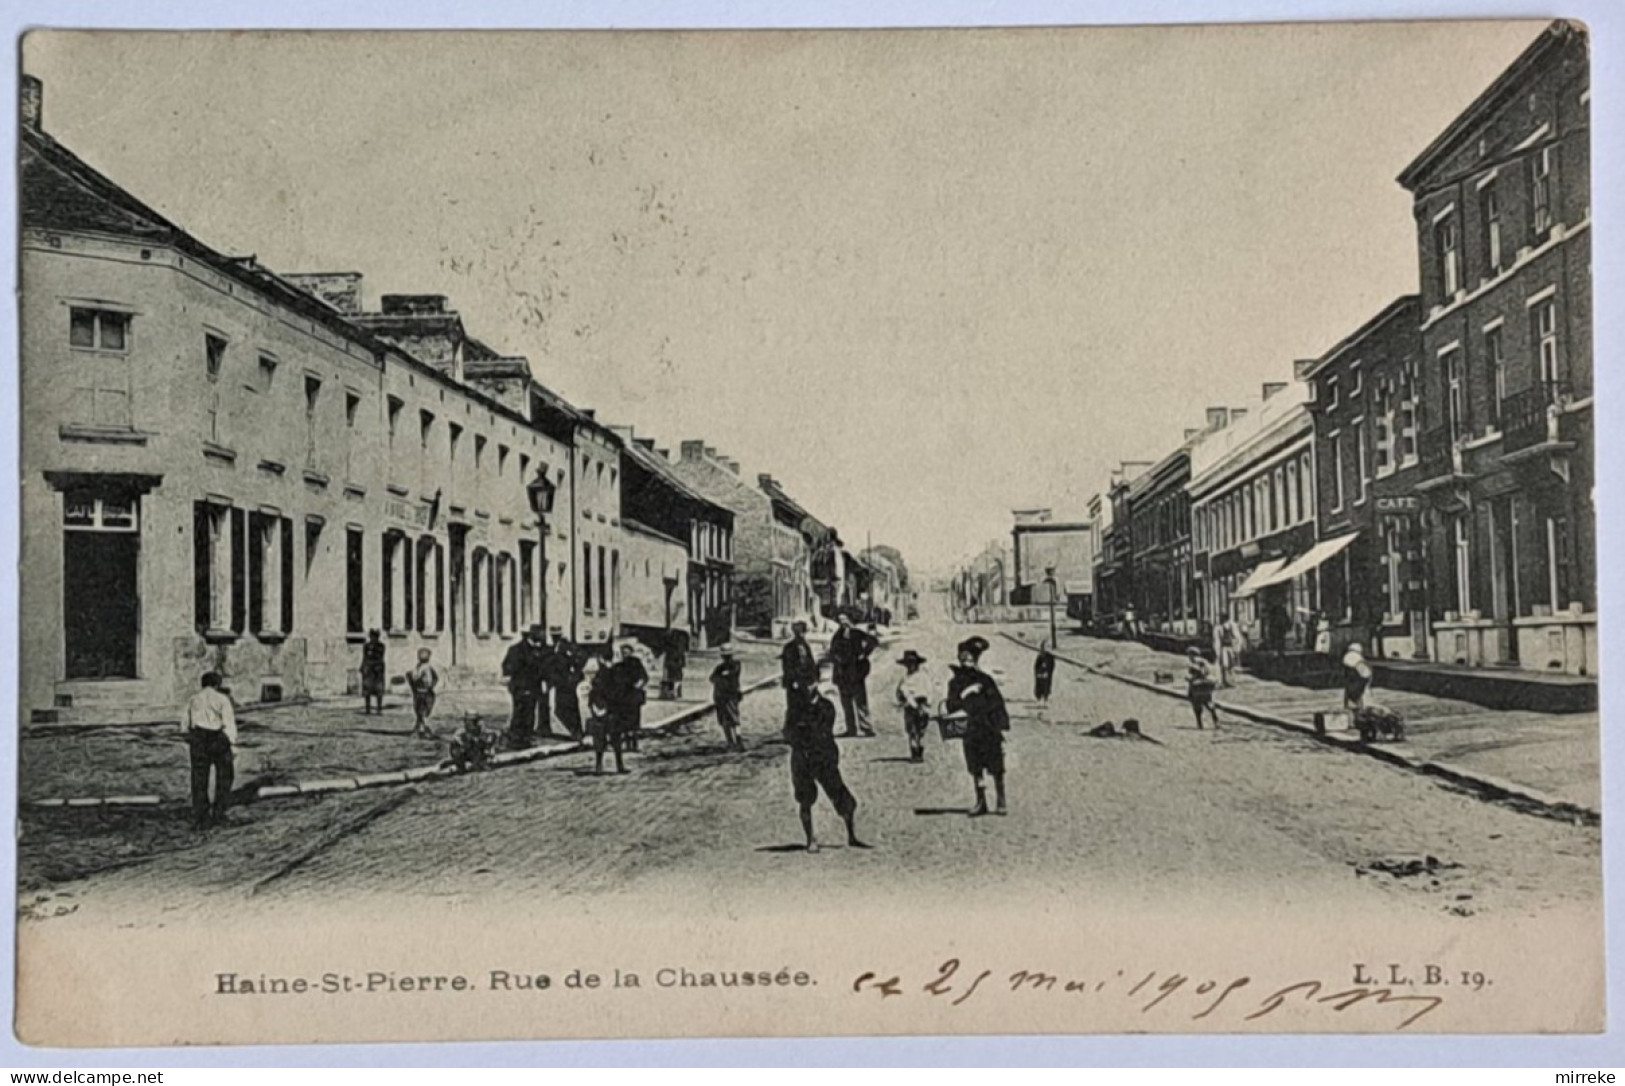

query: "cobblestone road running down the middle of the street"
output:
23 611 1601 923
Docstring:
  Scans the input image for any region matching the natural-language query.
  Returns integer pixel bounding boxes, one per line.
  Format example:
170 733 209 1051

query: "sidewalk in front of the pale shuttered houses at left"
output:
18 652 778 806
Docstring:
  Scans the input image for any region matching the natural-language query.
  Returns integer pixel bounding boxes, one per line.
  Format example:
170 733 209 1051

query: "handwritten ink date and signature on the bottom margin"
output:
852 958 1445 1032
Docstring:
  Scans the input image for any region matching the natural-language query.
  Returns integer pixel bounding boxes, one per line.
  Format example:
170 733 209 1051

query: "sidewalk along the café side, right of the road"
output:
1016 631 1602 810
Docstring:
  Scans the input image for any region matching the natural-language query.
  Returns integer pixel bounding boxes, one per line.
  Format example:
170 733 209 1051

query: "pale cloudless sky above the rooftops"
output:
23 21 1544 571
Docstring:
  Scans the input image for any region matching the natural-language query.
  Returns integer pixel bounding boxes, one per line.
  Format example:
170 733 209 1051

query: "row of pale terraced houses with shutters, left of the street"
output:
18 76 897 723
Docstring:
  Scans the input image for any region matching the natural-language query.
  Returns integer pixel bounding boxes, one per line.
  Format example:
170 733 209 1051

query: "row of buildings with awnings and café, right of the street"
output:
1090 23 1597 695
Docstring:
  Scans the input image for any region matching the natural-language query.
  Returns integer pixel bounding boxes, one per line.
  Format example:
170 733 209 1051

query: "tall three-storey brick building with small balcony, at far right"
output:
1399 23 1597 675
